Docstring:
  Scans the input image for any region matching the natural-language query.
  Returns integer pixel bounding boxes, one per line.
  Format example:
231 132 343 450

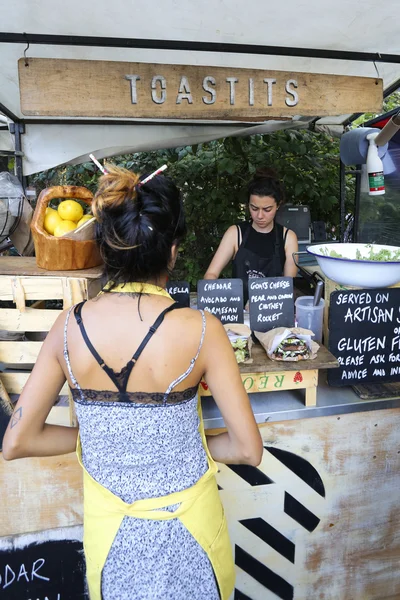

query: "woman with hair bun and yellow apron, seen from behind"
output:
3 166 262 600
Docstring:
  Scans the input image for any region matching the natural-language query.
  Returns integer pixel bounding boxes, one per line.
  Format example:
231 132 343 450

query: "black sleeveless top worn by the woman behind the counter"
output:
232 223 288 304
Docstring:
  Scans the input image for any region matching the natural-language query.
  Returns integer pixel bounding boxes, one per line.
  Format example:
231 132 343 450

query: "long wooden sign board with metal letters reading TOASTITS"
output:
18 58 383 120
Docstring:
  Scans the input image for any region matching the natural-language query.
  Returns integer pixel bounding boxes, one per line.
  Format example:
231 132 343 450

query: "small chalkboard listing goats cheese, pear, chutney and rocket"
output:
249 277 294 332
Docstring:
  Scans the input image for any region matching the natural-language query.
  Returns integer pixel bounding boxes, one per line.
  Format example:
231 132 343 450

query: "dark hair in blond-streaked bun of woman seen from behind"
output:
92 165 186 289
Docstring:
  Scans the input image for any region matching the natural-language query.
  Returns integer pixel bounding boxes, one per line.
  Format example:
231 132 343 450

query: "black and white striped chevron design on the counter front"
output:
217 446 325 600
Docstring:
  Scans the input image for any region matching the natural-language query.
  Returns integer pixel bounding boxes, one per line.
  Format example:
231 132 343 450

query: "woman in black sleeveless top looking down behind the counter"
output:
204 169 298 302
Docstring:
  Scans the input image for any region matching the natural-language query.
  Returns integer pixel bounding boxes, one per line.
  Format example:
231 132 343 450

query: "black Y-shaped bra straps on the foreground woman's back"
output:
74 300 183 392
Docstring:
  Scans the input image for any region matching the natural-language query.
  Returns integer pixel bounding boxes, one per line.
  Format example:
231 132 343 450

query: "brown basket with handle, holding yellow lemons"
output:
31 185 103 271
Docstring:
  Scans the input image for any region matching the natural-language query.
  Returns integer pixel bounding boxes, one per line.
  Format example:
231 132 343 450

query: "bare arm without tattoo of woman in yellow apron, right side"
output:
202 315 263 466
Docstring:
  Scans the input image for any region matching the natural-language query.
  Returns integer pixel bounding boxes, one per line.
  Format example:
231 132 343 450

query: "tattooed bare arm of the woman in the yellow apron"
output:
2 312 78 460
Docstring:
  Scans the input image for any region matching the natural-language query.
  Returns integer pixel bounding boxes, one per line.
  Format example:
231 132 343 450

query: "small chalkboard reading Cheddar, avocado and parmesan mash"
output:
197 279 244 323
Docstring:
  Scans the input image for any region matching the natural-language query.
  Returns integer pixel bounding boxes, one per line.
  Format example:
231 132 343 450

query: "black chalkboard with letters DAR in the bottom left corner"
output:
0 528 89 600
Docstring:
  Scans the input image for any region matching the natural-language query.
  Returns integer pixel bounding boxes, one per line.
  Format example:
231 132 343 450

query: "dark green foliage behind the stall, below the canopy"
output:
30 130 353 285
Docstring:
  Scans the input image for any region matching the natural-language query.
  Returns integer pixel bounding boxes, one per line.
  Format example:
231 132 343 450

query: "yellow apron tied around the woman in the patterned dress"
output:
77 284 235 600
